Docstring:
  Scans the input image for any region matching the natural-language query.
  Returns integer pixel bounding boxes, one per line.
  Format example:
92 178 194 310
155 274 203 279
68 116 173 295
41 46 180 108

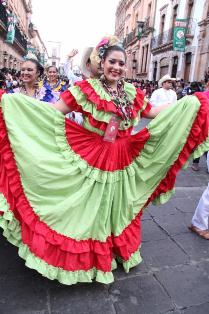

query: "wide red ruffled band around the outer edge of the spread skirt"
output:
0 93 209 271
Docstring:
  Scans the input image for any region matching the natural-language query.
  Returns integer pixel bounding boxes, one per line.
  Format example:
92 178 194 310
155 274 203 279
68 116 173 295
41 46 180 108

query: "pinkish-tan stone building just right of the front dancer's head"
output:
115 0 156 79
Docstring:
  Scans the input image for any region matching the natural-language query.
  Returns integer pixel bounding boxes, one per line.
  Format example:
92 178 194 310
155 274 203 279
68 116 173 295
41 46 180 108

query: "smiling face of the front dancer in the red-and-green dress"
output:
102 51 126 85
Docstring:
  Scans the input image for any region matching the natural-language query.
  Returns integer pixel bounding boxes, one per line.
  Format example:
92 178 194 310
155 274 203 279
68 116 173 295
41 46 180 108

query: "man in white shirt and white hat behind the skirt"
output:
150 74 177 107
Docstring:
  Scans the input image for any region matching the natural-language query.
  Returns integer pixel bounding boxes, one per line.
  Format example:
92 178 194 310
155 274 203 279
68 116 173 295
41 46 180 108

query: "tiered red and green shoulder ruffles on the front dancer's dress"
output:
61 80 151 131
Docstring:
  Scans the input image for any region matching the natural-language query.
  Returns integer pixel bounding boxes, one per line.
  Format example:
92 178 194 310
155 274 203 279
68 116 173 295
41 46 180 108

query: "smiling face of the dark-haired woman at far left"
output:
20 61 39 83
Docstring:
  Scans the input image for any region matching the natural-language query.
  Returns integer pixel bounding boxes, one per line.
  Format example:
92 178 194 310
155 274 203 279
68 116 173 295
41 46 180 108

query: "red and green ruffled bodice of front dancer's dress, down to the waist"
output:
61 79 151 137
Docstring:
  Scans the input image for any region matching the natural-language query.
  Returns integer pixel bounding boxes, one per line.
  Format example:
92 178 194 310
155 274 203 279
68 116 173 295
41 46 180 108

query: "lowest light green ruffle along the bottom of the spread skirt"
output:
0 196 142 285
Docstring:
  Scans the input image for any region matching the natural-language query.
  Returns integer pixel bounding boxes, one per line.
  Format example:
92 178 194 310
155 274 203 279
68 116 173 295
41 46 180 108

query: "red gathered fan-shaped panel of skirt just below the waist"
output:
65 119 150 171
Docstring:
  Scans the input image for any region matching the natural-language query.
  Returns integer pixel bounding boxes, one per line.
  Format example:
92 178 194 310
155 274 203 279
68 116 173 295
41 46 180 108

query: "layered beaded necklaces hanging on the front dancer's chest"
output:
100 77 133 124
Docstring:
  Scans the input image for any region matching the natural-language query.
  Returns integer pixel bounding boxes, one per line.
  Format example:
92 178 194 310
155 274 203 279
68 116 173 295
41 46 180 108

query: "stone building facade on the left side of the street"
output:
0 0 46 70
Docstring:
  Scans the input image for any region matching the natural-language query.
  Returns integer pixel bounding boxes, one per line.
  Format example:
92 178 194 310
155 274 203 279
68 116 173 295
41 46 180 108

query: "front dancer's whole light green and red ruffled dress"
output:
0 79 209 284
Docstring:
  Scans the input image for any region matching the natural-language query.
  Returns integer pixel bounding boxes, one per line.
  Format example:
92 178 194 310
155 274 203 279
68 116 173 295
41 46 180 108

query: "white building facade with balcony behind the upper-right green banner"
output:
148 0 208 81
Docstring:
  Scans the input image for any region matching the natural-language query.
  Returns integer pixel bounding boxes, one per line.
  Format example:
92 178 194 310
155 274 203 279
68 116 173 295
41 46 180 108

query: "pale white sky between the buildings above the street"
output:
32 0 120 64
